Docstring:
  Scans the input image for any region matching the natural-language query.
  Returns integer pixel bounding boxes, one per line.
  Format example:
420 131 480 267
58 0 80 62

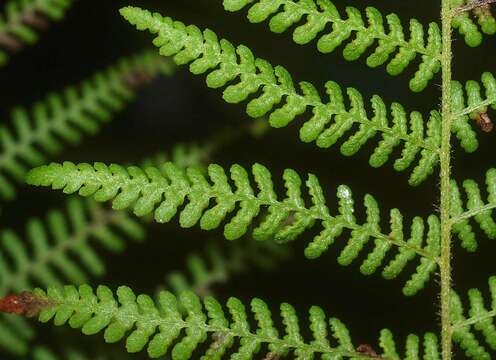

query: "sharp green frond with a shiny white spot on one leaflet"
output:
27 162 439 295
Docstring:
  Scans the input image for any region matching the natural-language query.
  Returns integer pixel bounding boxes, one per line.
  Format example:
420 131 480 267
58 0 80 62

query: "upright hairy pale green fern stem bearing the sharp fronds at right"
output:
439 0 453 360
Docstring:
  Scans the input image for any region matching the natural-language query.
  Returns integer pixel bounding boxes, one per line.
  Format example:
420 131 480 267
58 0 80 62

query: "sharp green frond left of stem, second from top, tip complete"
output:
121 7 450 185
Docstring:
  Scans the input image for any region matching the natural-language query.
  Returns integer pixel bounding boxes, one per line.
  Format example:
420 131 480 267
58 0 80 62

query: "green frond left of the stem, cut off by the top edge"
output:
224 0 441 92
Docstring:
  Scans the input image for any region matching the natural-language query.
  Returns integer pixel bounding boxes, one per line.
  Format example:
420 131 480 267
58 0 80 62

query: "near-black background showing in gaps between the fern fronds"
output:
0 0 496 359
